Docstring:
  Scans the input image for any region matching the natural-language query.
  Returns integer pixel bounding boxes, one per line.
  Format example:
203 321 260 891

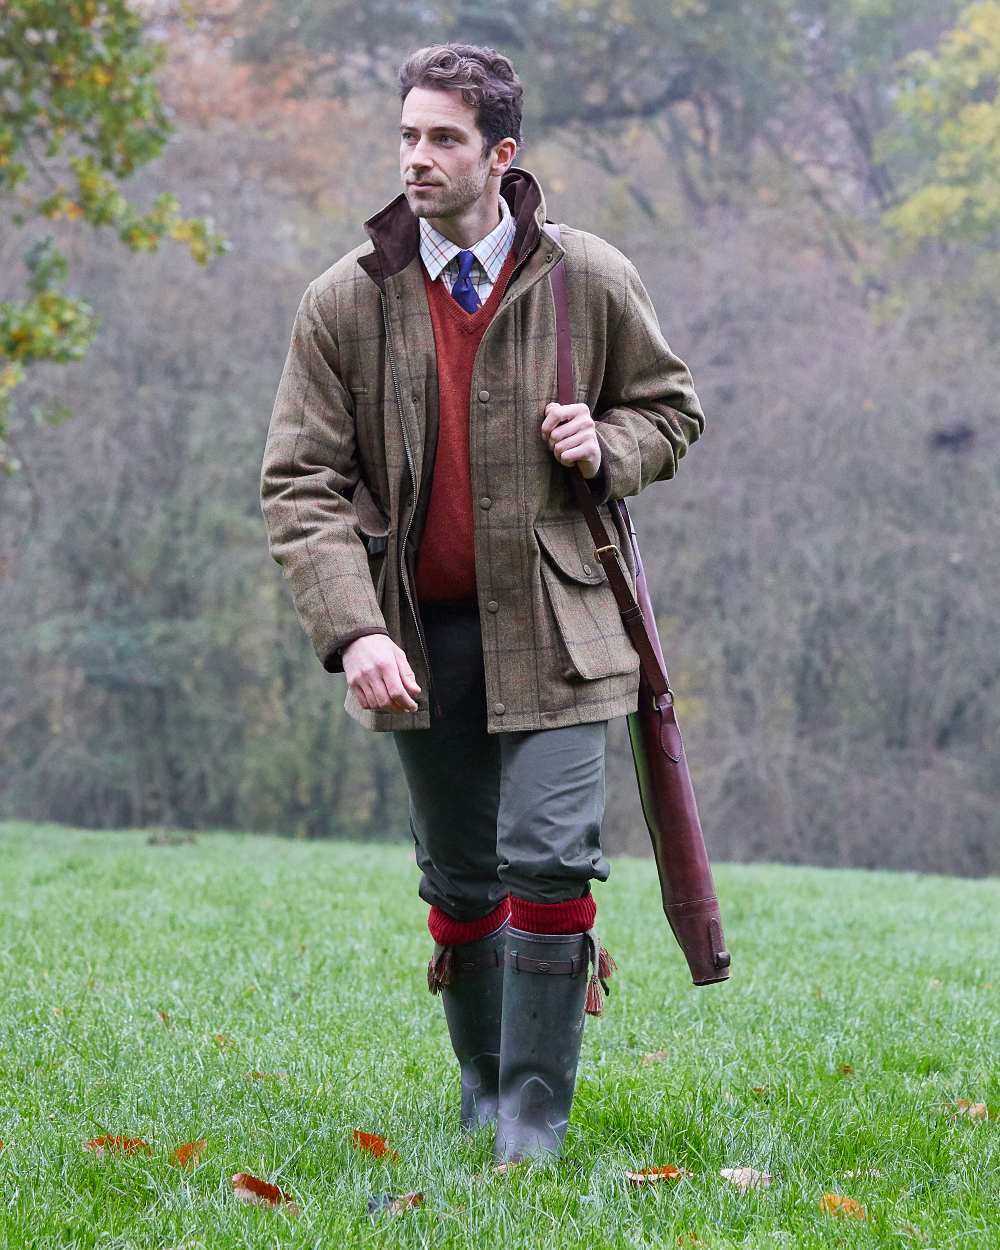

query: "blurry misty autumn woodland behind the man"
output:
0 0 1000 874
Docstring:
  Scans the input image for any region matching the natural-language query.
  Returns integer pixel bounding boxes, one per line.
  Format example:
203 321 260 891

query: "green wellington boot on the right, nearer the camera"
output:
494 926 614 1163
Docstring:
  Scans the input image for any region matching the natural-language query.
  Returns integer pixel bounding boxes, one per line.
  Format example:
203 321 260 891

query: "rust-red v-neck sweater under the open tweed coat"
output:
416 249 518 603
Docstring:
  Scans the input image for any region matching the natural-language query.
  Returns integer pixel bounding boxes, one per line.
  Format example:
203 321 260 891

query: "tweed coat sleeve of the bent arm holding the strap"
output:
591 258 705 504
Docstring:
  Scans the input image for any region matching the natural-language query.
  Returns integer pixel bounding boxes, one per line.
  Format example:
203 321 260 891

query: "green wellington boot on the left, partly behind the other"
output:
428 921 508 1133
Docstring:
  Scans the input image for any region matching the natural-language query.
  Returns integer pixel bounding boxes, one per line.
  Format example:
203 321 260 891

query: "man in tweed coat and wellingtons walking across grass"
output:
261 44 704 1163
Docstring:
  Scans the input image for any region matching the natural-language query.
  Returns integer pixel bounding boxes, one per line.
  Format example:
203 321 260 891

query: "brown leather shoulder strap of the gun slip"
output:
543 221 670 698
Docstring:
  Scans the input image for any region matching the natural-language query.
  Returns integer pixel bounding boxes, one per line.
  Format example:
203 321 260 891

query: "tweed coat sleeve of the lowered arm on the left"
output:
260 284 389 673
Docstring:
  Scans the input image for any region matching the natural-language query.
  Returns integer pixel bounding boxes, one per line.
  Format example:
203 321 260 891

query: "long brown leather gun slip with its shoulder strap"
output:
545 221 730 985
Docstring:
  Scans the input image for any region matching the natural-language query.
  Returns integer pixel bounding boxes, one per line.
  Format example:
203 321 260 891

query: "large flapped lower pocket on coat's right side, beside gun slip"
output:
535 518 639 680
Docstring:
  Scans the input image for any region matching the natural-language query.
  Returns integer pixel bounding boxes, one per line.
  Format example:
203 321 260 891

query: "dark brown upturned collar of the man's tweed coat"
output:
358 165 545 289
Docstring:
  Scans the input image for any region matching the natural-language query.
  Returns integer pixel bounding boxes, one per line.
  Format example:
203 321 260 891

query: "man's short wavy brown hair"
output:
399 44 524 158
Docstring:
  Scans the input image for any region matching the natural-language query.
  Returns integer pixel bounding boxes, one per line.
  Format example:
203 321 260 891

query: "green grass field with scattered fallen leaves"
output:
0 824 1000 1250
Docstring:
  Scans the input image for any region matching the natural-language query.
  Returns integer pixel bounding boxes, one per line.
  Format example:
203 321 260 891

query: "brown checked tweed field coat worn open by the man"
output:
260 166 705 733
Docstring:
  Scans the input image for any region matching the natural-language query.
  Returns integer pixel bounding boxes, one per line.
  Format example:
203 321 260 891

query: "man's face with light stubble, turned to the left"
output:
399 86 493 218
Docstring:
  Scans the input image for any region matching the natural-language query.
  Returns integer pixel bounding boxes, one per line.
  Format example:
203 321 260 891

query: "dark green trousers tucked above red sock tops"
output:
393 604 611 920
